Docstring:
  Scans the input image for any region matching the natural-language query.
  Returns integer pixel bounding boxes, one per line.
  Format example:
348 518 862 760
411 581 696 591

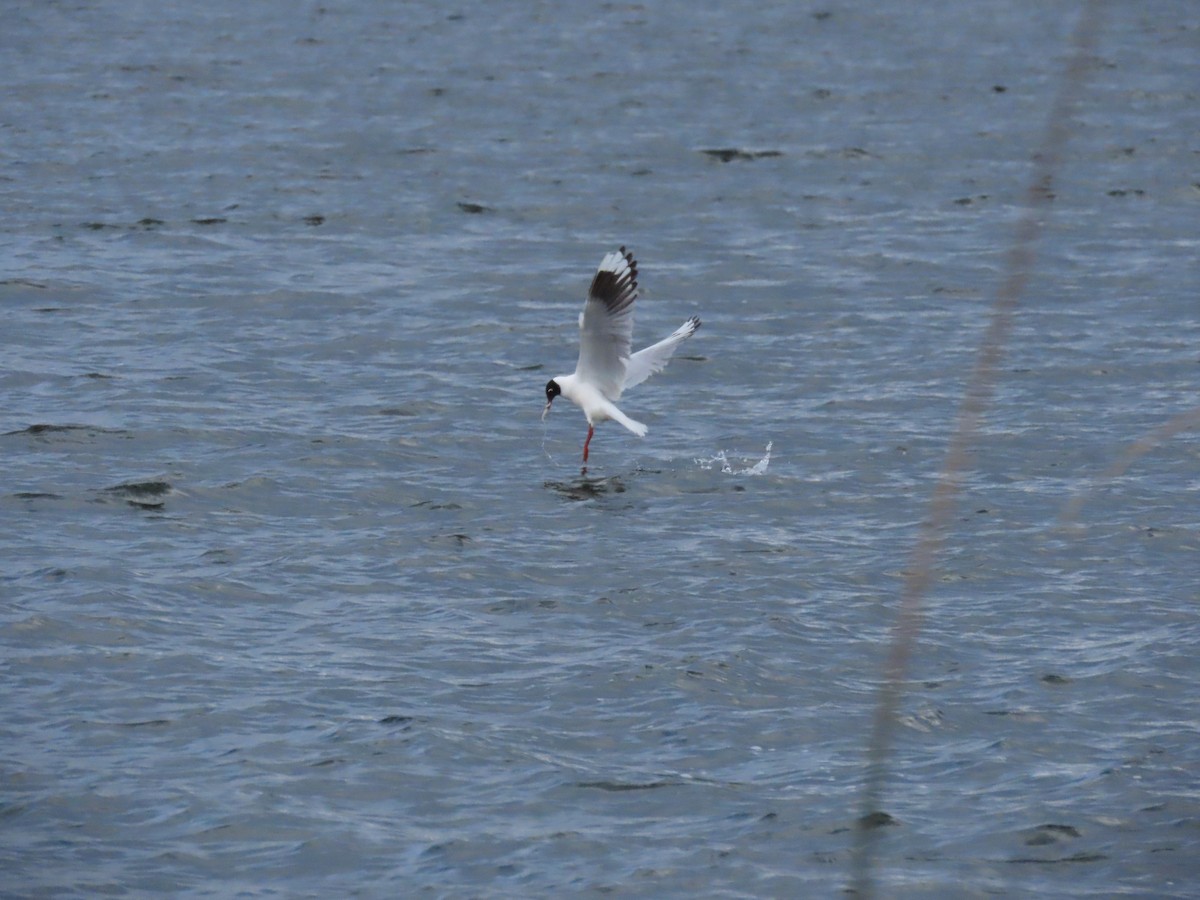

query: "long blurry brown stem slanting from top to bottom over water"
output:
851 0 1103 898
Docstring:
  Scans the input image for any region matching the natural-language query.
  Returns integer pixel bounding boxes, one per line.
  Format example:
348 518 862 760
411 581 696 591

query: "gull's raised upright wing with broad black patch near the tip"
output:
575 247 637 400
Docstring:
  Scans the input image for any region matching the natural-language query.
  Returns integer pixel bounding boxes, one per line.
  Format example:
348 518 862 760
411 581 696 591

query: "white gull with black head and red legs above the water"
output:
541 247 700 462
